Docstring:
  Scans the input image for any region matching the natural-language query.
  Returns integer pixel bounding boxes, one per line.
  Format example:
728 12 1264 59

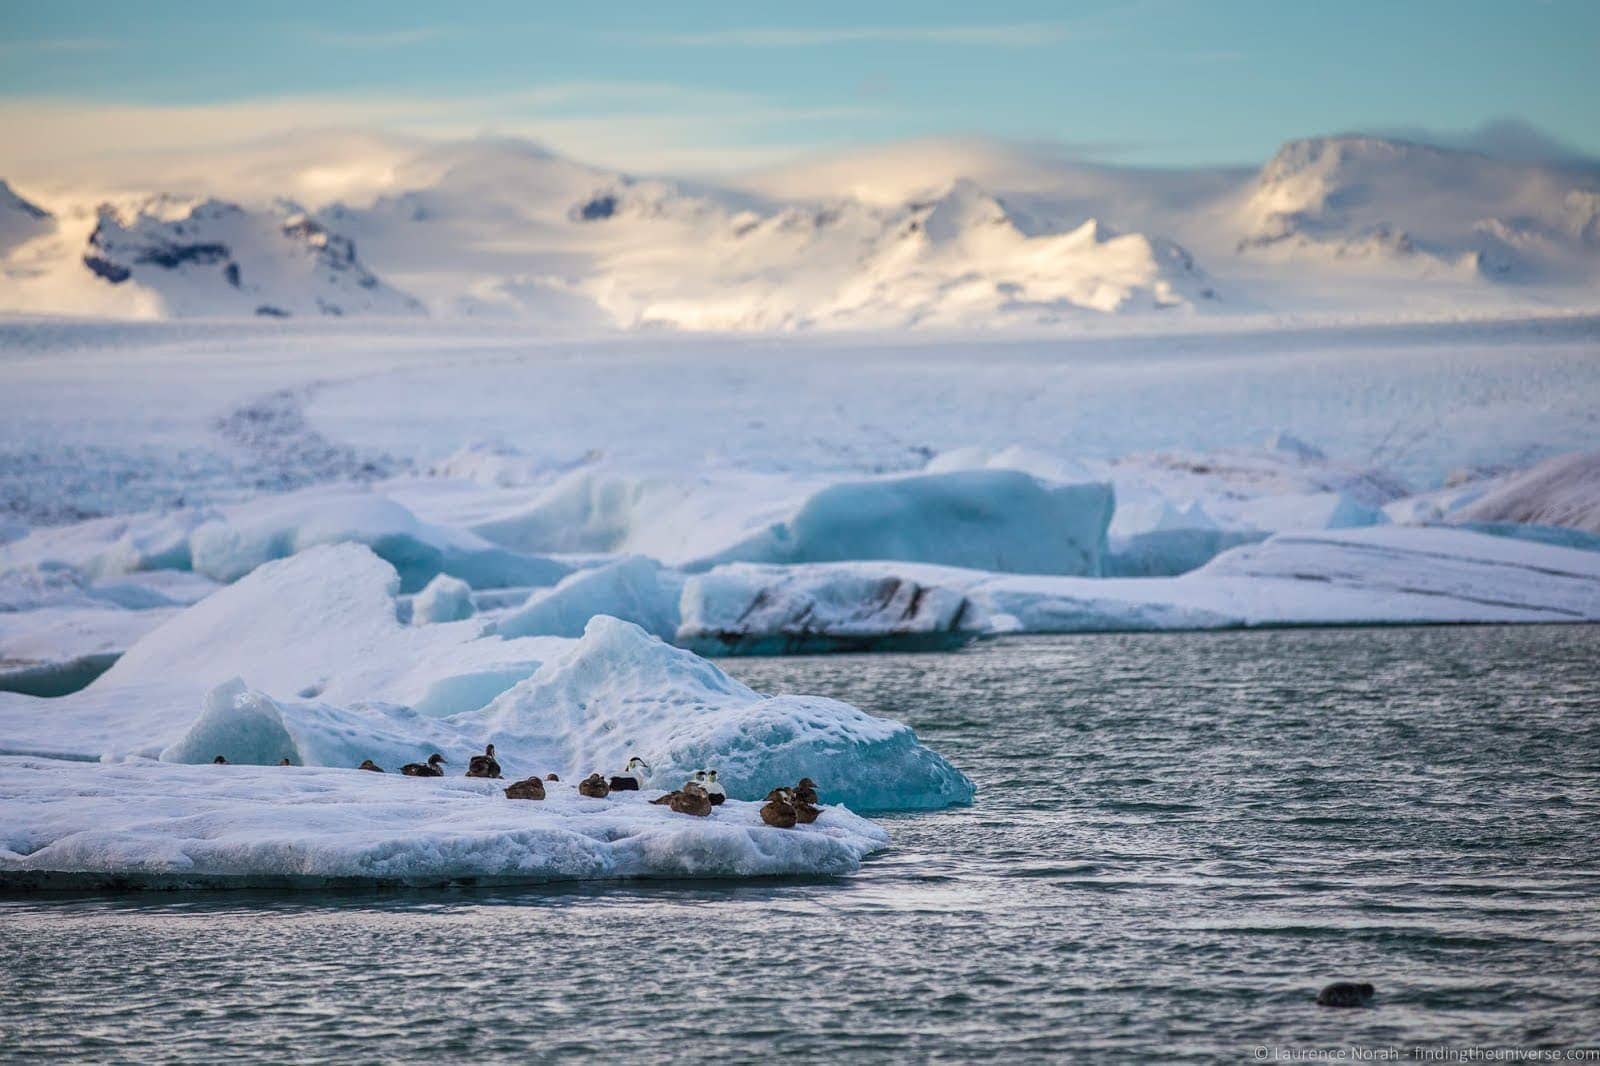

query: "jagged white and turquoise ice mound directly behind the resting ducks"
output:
0 544 973 810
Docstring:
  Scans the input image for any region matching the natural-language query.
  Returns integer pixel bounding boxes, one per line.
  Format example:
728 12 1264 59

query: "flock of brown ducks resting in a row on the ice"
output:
211 744 822 829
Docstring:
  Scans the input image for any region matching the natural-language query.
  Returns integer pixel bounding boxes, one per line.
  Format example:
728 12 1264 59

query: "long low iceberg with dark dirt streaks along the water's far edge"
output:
678 525 1600 653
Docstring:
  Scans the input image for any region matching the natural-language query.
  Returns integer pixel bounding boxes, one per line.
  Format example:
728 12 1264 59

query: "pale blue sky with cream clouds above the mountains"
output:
0 0 1600 174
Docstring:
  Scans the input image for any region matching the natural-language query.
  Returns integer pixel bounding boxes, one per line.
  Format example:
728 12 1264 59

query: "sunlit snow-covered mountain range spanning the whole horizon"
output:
0 128 1600 321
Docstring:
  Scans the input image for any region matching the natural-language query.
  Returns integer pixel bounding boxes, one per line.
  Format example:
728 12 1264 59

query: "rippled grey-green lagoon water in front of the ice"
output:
0 626 1600 1061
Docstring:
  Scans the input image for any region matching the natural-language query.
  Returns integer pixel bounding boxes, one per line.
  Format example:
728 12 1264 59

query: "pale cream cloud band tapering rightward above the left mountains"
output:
0 82 882 200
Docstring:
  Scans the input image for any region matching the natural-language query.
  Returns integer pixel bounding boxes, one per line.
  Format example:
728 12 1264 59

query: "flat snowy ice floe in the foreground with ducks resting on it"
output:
0 757 888 888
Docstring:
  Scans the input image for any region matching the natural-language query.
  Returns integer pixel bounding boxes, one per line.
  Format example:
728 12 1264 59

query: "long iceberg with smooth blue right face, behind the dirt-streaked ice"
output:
470 467 1114 575
